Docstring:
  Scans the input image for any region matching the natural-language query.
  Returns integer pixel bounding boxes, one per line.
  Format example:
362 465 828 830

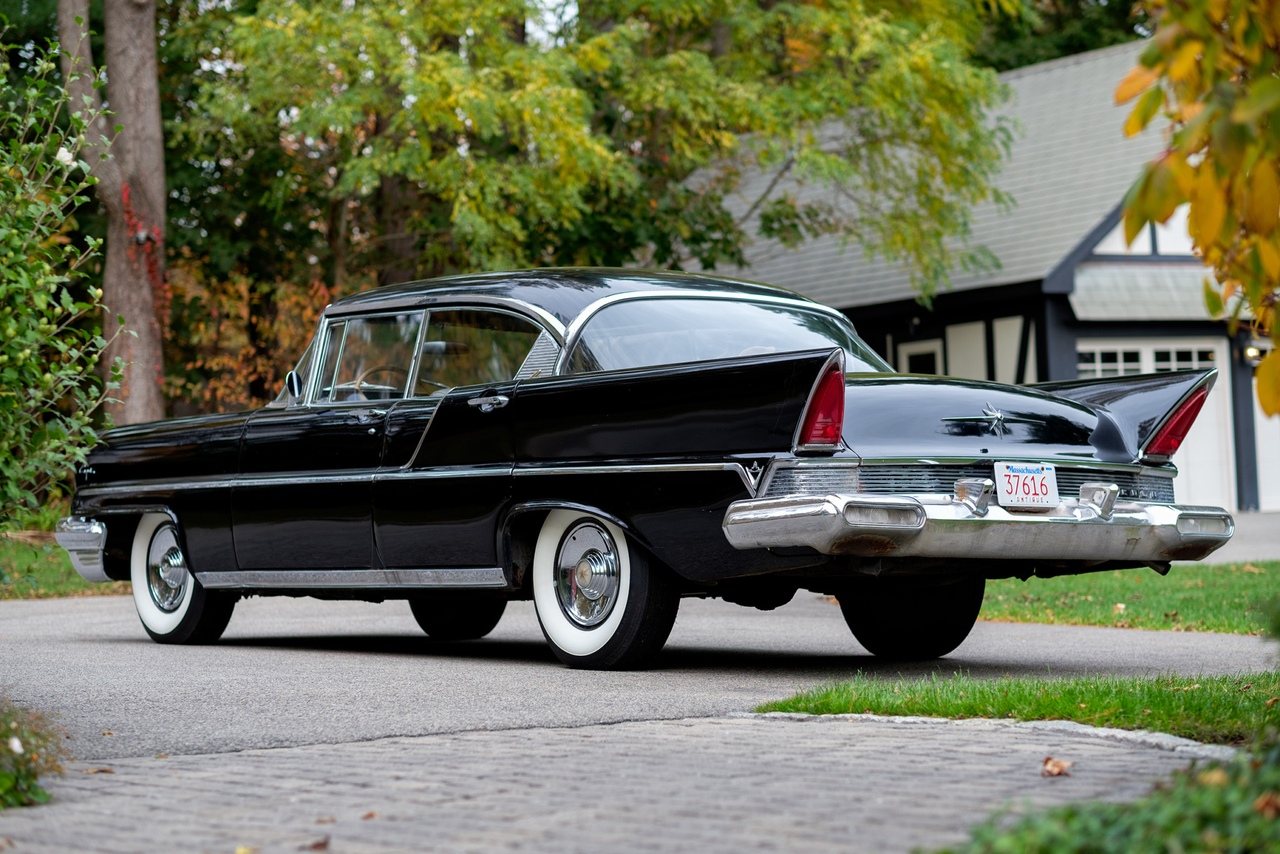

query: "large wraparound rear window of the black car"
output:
568 297 892 374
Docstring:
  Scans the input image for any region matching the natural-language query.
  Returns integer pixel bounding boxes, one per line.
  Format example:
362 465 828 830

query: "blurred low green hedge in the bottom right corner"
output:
946 750 1280 854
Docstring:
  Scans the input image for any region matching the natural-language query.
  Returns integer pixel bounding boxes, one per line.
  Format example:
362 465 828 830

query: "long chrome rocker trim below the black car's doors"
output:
195 567 508 590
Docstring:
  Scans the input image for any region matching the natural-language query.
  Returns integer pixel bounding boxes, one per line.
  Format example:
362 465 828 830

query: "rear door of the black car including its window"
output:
372 306 558 568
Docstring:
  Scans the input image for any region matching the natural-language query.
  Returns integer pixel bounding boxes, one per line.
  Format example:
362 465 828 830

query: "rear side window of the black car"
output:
413 309 543 397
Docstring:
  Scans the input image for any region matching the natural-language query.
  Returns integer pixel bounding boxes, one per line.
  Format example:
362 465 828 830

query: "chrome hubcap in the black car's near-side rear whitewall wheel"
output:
556 521 620 629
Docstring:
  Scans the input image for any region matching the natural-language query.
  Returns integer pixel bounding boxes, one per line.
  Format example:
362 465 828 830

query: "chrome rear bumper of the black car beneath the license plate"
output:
723 491 1235 563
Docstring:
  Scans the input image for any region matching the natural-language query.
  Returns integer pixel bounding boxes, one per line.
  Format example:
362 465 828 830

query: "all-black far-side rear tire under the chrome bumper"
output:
838 575 986 661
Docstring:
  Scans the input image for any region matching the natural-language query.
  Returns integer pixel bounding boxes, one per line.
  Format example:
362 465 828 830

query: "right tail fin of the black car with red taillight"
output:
1036 369 1217 463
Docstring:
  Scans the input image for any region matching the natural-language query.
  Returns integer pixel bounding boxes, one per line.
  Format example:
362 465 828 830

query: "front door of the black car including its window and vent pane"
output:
232 311 422 570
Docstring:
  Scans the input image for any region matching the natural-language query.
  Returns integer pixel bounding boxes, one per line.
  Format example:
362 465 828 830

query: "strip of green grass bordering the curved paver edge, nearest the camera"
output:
756 672 1280 744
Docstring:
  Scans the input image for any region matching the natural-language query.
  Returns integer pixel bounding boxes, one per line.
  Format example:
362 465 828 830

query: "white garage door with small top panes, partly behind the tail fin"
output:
1076 338 1235 510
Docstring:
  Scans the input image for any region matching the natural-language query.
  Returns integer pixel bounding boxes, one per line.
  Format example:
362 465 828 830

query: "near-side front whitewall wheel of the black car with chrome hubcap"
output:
129 513 236 644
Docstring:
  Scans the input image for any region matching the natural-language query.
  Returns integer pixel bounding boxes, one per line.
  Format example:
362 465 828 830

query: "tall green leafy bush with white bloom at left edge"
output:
0 33 113 525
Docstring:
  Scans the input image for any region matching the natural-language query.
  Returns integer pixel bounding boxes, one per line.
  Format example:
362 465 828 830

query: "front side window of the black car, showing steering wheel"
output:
315 312 422 403
